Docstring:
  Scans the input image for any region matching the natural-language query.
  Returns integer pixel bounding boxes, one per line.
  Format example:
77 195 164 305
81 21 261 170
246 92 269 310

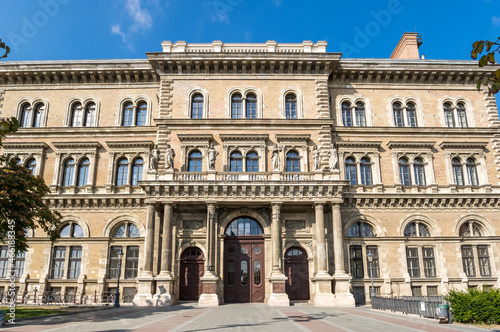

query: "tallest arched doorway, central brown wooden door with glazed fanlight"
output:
224 217 265 303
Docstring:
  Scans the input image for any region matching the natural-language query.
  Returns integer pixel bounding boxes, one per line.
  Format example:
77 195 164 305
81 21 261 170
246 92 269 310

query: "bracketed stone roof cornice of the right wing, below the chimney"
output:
330 59 500 86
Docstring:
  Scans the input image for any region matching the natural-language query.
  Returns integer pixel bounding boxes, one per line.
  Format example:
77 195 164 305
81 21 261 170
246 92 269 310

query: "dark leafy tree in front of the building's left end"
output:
0 118 61 251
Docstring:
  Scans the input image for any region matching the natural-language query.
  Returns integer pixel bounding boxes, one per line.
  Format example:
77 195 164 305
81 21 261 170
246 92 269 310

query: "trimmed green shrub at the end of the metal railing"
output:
444 288 500 324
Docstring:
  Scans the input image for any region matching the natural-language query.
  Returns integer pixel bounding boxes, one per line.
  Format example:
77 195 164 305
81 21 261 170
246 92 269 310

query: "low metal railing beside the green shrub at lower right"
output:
372 296 448 319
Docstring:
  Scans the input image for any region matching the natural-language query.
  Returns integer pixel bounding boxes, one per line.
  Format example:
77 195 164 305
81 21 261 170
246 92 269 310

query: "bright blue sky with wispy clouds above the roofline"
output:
0 0 500 105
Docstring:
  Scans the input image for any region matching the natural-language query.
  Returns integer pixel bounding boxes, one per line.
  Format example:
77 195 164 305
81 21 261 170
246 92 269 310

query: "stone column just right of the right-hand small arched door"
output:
313 202 335 306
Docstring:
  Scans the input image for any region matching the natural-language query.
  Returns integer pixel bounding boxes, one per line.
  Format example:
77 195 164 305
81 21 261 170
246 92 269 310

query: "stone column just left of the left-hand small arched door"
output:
155 202 175 306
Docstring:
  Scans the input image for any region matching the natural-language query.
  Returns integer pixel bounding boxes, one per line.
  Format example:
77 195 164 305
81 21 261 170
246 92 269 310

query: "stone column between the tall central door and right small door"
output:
267 203 290 306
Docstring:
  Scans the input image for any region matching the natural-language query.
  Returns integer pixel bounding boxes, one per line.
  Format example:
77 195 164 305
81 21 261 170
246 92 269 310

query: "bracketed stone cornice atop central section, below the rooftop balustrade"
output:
146 52 341 76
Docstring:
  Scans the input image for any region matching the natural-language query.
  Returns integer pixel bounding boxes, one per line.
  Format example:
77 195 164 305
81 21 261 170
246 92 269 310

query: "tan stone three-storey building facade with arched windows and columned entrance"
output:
0 33 500 306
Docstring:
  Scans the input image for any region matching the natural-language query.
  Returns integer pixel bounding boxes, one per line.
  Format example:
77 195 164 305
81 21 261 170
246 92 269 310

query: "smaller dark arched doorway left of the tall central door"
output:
179 247 205 301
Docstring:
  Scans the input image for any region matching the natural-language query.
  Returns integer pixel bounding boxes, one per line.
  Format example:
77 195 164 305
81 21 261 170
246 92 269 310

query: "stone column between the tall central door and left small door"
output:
198 201 219 307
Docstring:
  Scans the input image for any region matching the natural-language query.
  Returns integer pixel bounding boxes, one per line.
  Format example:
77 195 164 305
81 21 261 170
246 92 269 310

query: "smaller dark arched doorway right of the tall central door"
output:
285 247 310 301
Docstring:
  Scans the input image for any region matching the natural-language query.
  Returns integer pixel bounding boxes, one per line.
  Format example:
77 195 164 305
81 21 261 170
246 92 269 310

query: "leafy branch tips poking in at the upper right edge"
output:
471 37 500 95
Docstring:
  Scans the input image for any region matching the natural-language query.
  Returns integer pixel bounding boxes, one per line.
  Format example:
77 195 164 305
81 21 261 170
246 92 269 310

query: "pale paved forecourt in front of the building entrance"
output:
4 303 491 332
